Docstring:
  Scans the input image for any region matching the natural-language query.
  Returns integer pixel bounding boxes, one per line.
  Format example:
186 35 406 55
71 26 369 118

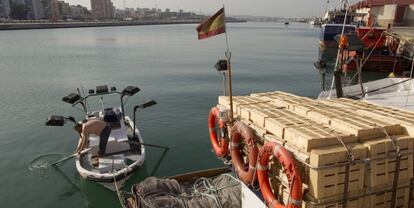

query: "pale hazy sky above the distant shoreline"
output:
64 0 356 17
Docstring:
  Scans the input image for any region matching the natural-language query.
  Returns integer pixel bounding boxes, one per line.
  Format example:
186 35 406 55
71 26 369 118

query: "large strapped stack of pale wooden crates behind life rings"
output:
219 91 414 208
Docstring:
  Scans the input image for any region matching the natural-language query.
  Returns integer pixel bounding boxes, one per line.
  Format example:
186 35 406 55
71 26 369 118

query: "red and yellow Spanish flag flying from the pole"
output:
196 8 226 40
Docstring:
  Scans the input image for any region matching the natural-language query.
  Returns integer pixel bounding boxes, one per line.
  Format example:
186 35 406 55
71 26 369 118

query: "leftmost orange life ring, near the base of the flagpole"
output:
208 107 229 158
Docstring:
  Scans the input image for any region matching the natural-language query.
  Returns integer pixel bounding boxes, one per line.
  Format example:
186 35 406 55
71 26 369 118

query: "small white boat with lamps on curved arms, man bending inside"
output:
46 85 156 188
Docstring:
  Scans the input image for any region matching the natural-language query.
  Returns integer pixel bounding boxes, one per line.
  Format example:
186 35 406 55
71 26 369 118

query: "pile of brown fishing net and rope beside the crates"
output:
133 174 241 208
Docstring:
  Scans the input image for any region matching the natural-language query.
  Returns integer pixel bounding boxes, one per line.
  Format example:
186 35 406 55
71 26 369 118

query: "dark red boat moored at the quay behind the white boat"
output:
341 27 409 74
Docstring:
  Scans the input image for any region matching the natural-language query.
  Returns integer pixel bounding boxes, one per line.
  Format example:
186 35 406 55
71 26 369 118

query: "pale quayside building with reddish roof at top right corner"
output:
351 0 414 27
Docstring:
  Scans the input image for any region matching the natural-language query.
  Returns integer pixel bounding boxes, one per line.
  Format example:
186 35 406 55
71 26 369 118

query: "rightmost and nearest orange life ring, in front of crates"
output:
257 142 302 208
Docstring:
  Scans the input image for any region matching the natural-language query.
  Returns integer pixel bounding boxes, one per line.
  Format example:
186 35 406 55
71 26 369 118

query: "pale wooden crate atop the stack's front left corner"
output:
284 124 358 152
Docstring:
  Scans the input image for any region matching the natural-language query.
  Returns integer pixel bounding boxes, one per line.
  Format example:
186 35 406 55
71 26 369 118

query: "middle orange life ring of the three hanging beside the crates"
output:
230 121 259 184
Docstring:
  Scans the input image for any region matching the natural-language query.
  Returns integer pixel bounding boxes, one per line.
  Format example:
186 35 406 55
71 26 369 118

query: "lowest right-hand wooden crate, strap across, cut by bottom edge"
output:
364 188 410 208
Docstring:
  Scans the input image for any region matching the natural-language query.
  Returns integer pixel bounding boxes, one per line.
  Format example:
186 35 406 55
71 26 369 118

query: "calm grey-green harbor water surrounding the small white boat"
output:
0 23 320 208
